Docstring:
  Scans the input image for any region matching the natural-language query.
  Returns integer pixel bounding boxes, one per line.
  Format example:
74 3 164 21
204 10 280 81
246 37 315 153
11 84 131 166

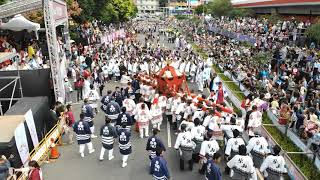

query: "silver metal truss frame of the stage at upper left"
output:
0 0 71 104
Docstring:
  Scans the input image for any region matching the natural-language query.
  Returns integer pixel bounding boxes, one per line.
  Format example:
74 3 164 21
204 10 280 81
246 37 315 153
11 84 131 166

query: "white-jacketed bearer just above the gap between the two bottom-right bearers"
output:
247 132 270 168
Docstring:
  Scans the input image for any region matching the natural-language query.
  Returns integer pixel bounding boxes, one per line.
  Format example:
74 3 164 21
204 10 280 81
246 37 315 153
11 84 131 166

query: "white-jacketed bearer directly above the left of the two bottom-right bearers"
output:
225 129 245 160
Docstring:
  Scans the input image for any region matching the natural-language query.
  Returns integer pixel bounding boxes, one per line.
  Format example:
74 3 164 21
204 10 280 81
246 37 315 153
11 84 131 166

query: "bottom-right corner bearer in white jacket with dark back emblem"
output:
260 145 287 179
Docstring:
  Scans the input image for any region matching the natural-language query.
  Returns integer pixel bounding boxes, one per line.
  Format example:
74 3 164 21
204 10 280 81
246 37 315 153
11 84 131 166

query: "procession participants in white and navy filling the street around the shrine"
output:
54 18 287 179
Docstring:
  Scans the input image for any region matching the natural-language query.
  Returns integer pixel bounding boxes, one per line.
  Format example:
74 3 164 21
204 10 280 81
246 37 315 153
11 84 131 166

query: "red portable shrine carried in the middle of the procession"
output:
156 65 190 95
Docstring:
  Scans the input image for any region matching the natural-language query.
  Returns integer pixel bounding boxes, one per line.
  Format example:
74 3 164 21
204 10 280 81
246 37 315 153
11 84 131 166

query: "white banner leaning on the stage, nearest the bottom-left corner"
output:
14 123 29 165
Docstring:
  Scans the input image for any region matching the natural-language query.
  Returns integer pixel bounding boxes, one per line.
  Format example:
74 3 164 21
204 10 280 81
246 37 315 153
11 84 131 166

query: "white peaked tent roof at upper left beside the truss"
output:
0 14 40 31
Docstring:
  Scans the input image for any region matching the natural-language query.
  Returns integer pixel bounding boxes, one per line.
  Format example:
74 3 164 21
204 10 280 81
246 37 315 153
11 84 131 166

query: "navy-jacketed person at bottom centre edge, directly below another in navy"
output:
150 148 170 180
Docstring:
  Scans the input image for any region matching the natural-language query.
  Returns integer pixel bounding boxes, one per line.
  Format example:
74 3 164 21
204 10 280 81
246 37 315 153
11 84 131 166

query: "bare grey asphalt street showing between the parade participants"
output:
43 30 230 180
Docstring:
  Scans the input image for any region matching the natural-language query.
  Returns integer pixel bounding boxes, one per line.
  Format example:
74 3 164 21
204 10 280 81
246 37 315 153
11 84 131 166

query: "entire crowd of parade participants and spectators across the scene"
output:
0 14 320 180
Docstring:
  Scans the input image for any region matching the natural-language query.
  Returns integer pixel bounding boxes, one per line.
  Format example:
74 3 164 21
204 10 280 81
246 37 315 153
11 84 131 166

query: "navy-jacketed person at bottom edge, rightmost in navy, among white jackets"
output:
206 152 222 180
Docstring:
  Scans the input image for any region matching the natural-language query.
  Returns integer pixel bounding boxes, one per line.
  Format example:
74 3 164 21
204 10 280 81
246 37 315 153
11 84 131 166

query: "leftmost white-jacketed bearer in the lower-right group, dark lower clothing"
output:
174 124 196 170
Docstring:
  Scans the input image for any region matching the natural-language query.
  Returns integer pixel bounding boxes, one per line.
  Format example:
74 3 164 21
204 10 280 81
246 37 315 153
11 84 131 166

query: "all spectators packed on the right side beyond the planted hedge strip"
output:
185 15 320 145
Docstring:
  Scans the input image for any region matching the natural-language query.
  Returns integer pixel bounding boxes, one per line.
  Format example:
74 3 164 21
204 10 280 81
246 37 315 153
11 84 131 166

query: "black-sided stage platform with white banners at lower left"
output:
0 97 49 168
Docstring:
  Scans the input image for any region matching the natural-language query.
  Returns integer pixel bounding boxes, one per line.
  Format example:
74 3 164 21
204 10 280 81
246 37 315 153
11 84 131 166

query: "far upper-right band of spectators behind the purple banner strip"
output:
206 17 311 49
